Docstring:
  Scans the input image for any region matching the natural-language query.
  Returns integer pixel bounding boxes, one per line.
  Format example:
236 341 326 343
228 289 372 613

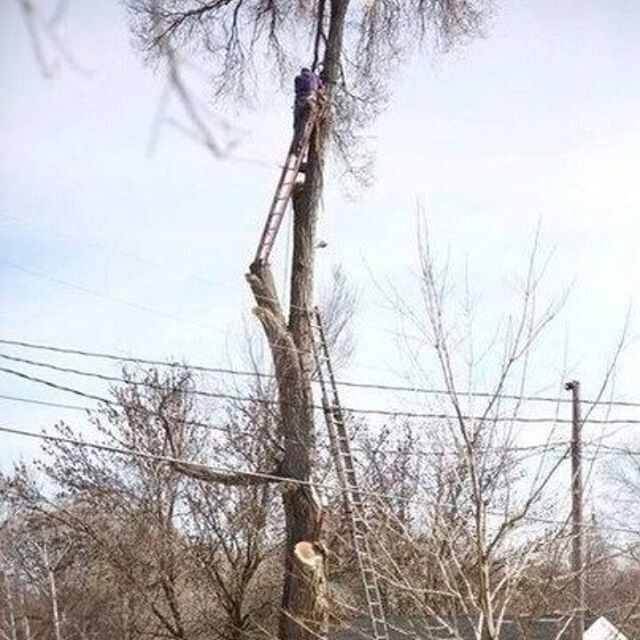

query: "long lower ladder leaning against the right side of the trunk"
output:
309 308 389 640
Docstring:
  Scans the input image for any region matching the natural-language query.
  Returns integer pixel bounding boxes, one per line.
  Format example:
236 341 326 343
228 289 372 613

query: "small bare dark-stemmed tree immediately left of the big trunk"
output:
181 377 281 640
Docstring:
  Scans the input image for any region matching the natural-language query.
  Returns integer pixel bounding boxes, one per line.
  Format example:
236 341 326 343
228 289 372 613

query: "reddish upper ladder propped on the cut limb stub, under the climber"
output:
254 105 322 264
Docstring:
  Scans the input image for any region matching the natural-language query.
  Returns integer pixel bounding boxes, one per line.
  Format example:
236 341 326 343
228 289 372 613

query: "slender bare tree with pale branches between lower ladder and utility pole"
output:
356 231 608 639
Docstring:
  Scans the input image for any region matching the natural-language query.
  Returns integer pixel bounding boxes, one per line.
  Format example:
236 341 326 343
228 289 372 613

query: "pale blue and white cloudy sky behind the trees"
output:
0 0 640 480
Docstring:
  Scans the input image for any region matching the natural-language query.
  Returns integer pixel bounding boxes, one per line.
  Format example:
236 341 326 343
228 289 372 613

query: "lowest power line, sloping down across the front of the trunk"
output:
0 426 638 535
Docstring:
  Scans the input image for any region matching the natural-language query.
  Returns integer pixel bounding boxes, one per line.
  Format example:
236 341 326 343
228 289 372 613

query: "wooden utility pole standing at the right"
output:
564 380 584 640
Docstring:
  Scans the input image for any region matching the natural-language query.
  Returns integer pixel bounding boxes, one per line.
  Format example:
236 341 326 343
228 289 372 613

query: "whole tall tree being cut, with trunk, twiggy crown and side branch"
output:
131 0 485 640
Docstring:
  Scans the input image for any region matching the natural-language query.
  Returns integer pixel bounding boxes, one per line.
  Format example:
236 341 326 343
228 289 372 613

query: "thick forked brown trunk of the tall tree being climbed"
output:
247 0 349 640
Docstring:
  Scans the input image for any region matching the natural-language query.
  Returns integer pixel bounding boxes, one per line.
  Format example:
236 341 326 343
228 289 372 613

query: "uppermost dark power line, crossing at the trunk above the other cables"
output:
0 338 640 407
